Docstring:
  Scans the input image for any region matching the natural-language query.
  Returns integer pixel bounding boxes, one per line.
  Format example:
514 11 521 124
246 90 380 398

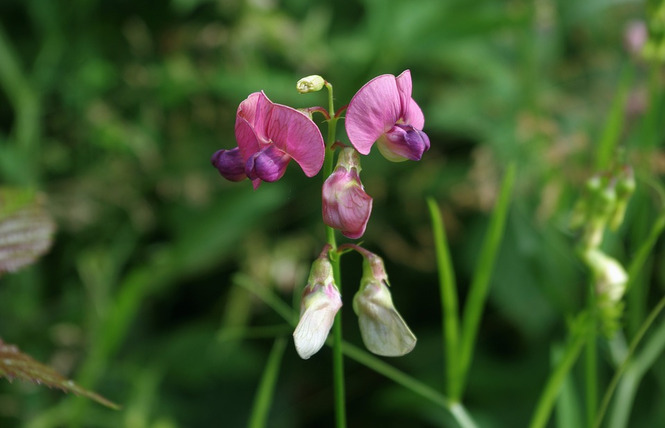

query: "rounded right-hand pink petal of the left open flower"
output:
266 104 325 177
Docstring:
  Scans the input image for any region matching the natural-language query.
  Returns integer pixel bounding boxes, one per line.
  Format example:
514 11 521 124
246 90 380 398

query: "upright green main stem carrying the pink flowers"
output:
323 82 346 428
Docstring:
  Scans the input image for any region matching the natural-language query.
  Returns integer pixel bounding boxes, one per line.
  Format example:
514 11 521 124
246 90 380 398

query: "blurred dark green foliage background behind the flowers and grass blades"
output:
0 0 665 428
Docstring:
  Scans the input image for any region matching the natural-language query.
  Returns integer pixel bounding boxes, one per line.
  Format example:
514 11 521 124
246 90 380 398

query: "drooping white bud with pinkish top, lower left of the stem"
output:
293 254 342 360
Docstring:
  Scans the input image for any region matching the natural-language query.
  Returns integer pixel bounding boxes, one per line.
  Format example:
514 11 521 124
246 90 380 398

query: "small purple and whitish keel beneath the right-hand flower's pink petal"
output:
378 125 430 162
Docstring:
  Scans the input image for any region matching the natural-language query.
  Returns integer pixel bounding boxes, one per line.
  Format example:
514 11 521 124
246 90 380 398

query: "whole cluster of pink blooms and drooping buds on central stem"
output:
212 70 430 359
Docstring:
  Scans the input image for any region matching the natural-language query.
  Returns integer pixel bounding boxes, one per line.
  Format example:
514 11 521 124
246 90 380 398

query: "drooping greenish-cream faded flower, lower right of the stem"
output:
353 252 417 357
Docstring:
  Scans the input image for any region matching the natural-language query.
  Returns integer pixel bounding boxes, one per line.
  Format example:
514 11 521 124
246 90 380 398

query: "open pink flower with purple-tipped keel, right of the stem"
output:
345 70 430 162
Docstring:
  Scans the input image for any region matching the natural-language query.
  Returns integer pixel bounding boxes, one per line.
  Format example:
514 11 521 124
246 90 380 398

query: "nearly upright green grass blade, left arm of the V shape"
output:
427 198 461 402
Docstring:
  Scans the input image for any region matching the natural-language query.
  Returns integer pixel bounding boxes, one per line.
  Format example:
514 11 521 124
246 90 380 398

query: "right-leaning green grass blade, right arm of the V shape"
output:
458 164 515 397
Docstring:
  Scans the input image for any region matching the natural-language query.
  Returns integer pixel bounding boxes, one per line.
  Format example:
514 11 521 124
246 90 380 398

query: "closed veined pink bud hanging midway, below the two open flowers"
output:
321 147 372 239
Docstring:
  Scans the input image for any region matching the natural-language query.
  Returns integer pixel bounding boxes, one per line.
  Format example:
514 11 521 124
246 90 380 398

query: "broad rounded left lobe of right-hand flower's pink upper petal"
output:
344 74 402 155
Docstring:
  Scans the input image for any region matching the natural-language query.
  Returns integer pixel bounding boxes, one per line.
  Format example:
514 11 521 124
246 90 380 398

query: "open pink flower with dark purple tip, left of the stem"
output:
212 91 325 189
